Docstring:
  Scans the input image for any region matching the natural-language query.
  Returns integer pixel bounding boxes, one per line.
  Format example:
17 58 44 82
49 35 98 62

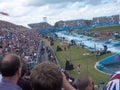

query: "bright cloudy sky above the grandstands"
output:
0 0 120 26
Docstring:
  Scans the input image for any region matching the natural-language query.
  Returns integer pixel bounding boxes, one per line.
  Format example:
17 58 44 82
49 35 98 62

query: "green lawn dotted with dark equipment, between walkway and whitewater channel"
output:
53 40 112 84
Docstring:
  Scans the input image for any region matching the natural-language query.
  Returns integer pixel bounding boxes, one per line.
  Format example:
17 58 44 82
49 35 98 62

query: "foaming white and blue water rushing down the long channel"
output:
56 32 120 53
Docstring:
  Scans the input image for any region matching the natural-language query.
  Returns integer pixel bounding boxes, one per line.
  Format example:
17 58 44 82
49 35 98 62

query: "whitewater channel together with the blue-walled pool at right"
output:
56 32 120 74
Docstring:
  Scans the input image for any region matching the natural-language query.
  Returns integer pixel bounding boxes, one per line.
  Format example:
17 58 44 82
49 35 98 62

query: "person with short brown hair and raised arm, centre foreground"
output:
30 61 75 90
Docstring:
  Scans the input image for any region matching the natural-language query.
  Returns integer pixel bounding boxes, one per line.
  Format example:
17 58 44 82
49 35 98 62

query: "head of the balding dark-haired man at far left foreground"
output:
0 54 21 77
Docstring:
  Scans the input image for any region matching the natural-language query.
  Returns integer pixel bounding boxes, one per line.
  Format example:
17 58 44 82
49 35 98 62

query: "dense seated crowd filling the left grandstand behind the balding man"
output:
0 21 42 67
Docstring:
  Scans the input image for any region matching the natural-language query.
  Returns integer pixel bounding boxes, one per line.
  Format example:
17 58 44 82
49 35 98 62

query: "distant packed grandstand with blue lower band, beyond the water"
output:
28 15 120 34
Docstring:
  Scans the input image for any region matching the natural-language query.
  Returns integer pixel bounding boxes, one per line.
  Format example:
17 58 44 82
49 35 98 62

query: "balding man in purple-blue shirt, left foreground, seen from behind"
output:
0 54 22 90
